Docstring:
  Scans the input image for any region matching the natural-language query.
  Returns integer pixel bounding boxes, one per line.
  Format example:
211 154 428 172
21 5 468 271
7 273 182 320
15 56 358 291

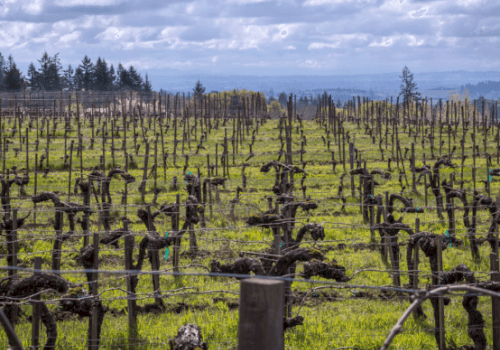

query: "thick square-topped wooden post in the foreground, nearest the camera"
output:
238 278 285 350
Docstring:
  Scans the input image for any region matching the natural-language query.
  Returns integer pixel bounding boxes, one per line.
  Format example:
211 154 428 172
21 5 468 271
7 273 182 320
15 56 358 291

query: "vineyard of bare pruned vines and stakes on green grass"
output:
0 92 500 350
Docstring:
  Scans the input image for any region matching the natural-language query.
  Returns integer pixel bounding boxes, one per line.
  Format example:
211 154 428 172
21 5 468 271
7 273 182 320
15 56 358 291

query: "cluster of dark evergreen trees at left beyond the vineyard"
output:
0 52 152 92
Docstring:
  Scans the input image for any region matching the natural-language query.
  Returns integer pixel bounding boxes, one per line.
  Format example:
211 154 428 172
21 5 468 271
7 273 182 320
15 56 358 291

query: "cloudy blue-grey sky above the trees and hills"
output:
0 0 500 79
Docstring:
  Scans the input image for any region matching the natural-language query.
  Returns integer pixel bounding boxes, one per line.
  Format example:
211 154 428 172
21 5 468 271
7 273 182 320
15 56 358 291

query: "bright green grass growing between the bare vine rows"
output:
0 102 500 350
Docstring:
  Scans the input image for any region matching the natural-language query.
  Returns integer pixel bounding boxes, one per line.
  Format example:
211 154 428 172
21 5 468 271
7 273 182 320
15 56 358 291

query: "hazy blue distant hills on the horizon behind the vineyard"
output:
149 70 500 99
